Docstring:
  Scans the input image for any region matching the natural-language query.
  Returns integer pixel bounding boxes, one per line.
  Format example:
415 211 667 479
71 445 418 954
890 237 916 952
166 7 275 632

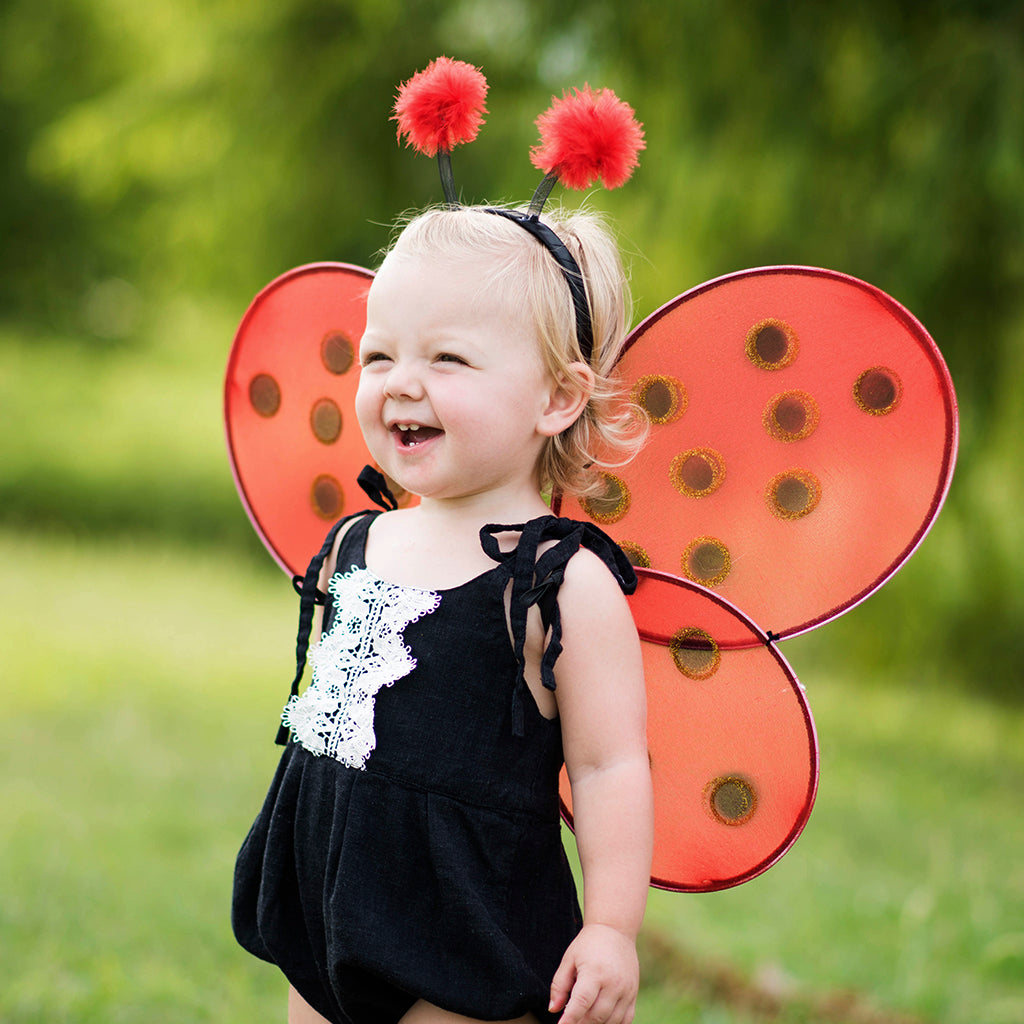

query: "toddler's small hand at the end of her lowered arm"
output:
550 925 640 1024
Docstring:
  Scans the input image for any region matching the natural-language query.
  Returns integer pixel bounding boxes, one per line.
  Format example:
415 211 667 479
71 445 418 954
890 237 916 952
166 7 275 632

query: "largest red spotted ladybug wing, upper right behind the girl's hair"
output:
558 267 956 637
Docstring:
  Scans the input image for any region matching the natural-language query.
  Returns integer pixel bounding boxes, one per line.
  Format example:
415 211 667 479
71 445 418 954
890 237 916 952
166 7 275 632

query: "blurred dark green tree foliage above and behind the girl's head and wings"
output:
0 0 1024 688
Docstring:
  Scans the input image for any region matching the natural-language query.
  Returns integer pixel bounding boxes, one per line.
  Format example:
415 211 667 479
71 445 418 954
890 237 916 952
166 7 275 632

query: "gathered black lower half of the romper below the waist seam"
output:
232 742 582 1024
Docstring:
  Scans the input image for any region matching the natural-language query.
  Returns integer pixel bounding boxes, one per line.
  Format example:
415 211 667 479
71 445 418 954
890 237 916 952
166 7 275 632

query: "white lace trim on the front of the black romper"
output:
282 565 441 768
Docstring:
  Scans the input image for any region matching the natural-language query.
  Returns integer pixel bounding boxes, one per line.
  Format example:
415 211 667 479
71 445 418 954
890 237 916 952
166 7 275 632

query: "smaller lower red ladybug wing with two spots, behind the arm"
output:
561 568 818 892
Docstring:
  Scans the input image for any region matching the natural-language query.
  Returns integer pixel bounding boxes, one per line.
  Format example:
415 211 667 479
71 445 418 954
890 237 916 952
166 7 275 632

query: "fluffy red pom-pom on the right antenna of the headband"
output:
530 85 645 188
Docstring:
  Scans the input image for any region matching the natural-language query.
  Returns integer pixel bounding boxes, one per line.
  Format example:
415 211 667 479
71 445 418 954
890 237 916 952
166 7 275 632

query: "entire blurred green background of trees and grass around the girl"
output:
0 0 1024 1024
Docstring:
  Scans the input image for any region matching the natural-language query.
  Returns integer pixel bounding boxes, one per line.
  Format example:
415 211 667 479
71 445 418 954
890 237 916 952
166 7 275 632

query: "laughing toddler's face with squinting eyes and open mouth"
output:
355 251 554 499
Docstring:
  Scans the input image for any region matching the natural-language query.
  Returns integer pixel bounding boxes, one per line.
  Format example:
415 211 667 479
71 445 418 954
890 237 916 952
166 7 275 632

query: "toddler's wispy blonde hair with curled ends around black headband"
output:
392 206 647 496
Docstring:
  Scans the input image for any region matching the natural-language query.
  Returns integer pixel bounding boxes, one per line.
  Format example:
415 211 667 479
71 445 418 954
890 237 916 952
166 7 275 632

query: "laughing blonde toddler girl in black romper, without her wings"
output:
233 207 651 1024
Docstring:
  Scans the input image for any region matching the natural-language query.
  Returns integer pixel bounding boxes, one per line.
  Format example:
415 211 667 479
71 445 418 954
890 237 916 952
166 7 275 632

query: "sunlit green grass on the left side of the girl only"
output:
0 536 293 1024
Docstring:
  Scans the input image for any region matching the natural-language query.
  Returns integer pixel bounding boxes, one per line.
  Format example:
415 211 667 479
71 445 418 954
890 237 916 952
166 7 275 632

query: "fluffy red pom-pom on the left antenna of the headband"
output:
392 57 487 157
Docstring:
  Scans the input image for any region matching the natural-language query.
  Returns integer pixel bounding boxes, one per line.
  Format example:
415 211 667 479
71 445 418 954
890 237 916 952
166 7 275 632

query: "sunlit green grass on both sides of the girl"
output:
0 531 1024 1024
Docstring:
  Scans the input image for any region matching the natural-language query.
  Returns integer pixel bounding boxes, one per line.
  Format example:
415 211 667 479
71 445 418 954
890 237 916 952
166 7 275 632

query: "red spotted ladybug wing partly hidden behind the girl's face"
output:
224 263 415 574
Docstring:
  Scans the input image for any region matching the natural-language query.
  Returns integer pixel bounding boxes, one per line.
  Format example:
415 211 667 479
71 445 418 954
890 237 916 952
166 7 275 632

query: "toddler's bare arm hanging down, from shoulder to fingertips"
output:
552 551 653 1024
